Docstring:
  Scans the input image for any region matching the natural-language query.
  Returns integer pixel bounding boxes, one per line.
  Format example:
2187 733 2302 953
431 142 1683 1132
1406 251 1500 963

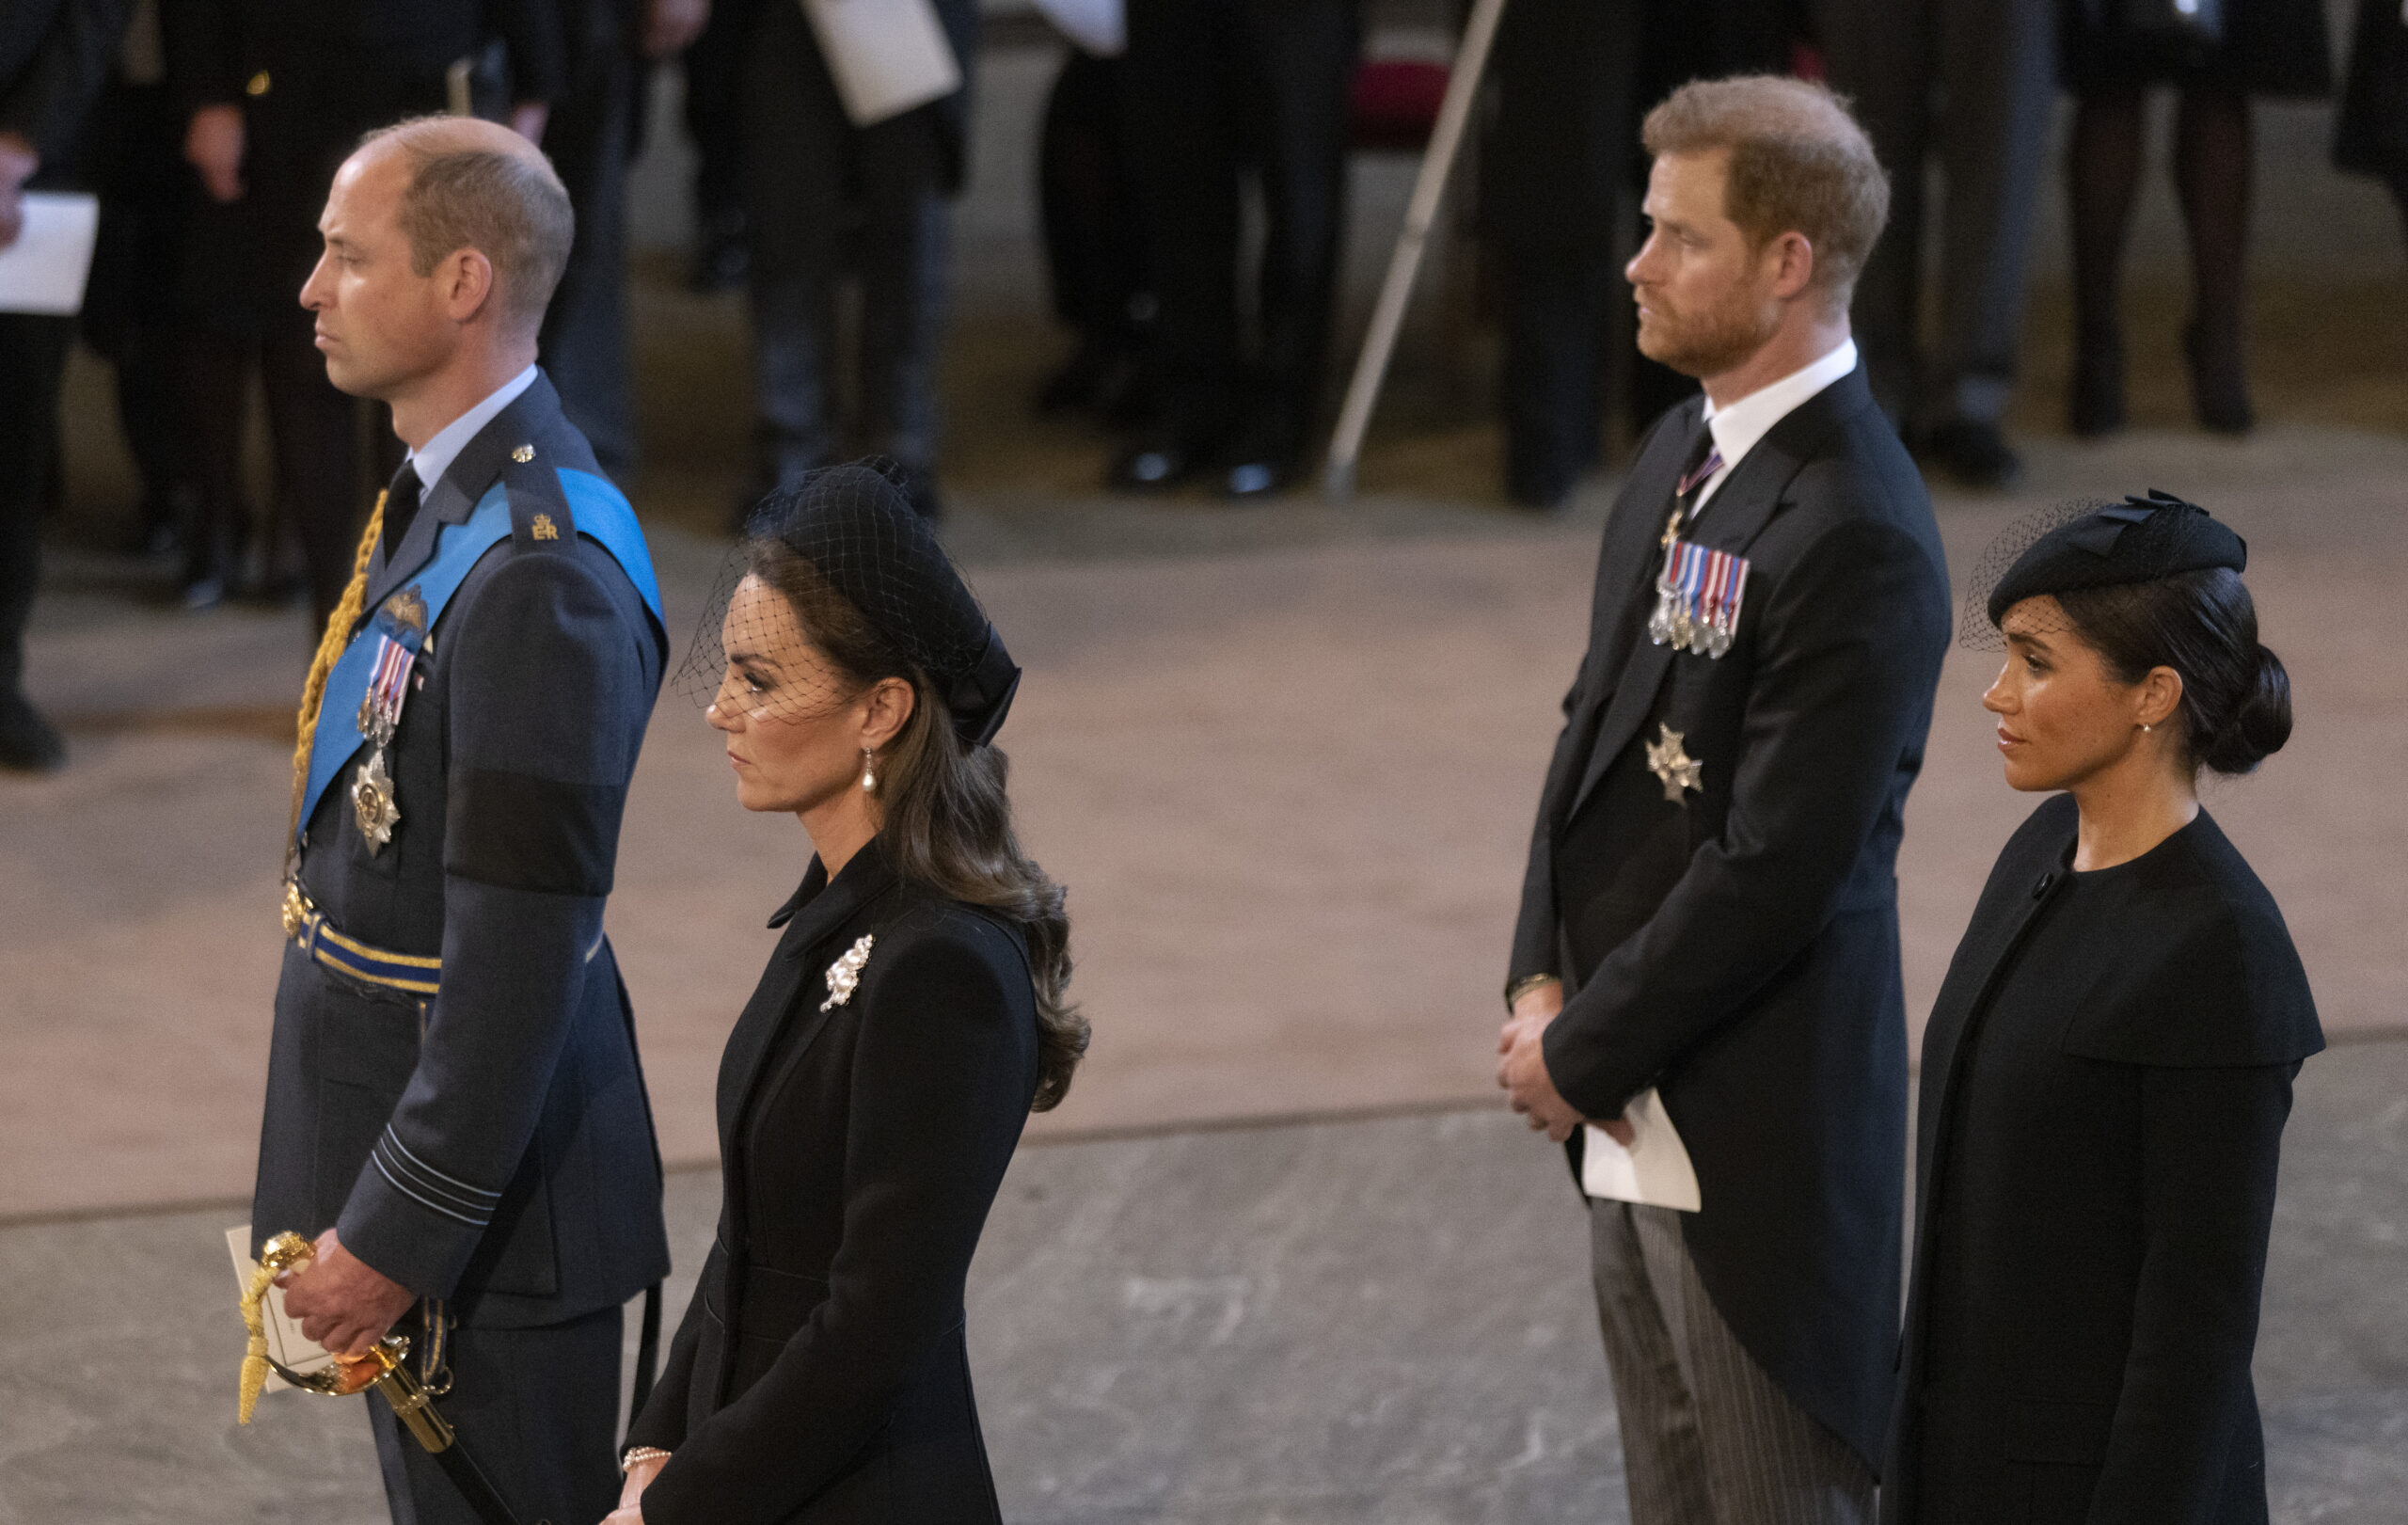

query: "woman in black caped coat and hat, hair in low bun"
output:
1880 497 2323 1525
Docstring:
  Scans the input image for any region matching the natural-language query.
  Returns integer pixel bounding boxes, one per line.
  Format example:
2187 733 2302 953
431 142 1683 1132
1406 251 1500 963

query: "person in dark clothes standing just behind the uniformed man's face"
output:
164 0 563 627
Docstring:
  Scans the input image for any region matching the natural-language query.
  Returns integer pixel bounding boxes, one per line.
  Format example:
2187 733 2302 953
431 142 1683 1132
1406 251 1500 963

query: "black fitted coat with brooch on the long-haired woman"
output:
628 841 1038 1525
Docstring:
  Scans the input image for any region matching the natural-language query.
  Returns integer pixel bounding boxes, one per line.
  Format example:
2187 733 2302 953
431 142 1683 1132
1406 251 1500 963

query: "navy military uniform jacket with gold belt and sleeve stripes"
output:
250 375 670 1327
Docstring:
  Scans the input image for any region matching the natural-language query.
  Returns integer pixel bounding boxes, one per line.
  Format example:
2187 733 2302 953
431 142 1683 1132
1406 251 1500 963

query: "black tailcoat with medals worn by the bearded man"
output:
1510 366 1948 1465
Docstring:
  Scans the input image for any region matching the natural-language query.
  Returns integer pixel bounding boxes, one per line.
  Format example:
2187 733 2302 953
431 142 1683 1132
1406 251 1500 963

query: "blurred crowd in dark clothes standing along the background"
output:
0 0 2408 769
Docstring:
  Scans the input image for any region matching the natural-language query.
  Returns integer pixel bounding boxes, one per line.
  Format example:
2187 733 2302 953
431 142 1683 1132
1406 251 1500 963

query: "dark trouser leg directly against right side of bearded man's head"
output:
1818 0 1936 420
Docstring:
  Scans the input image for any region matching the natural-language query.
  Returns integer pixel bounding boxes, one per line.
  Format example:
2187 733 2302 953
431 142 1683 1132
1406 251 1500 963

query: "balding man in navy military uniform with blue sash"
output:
253 118 670 1525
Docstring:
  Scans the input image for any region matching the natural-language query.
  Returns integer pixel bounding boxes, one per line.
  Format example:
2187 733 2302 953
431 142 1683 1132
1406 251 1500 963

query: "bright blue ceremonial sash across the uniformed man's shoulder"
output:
296 468 667 836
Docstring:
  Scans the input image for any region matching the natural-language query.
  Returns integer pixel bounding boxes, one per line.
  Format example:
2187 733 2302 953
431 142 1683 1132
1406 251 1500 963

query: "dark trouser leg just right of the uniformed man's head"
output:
542 39 636 474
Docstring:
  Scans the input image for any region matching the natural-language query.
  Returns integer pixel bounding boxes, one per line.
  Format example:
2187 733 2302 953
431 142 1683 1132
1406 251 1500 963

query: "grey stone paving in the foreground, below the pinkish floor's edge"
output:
0 1040 2408 1525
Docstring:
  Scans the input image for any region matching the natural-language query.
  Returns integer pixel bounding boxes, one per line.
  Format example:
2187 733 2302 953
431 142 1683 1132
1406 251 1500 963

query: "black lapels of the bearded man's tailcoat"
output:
1562 366 1874 821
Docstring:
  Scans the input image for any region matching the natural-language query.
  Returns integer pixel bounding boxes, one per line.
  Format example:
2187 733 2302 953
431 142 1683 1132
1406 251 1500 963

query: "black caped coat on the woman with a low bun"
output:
1880 795 2323 1525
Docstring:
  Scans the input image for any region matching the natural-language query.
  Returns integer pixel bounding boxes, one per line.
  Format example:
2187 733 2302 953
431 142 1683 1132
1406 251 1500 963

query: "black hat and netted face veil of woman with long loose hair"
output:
676 463 1021 747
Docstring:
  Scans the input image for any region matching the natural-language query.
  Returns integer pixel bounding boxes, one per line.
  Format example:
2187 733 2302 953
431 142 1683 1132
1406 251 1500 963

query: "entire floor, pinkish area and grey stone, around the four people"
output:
0 21 2408 1525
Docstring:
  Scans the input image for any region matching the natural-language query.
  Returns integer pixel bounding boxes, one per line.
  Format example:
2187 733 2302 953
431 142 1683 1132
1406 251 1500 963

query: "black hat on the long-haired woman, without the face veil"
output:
687 460 1021 747
